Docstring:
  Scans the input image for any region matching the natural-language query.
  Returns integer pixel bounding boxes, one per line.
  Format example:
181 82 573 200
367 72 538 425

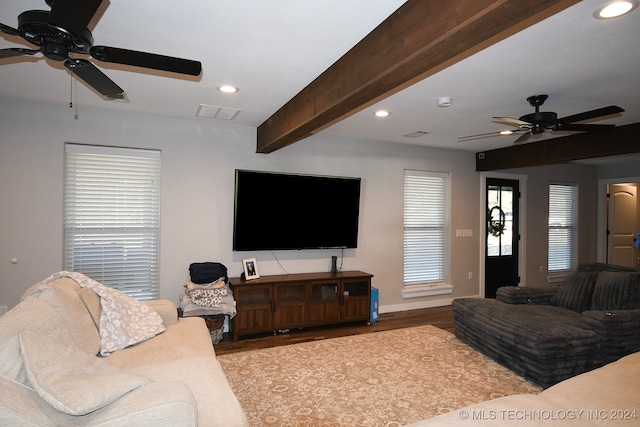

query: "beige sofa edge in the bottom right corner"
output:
410 353 640 427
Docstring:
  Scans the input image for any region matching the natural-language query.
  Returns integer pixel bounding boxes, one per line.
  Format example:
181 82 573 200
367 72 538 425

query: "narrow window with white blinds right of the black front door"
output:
548 184 578 273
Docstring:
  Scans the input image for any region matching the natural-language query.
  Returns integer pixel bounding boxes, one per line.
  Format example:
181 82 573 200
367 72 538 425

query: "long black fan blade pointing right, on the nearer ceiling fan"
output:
91 46 202 76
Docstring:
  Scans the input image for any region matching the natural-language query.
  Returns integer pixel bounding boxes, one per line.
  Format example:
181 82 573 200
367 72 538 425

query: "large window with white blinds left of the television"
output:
64 144 160 300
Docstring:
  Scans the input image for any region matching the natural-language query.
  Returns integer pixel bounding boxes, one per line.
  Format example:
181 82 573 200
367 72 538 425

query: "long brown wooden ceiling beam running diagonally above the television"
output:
257 0 579 153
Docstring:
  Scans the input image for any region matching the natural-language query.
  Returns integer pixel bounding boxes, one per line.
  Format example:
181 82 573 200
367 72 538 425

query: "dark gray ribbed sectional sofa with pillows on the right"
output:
453 263 640 388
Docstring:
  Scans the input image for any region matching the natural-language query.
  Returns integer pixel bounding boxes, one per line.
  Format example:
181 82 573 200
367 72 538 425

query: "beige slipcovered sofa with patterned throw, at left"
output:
0 277 248 427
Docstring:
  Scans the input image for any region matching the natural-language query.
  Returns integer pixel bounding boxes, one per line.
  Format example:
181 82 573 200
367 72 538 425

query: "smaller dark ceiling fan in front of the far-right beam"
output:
458 95 624 144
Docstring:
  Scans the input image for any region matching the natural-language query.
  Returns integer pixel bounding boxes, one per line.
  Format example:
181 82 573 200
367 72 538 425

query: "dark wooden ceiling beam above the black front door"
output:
476 123 640 171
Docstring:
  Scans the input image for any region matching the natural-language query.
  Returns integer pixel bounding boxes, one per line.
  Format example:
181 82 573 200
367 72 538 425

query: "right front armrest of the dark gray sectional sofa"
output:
582 309 640 362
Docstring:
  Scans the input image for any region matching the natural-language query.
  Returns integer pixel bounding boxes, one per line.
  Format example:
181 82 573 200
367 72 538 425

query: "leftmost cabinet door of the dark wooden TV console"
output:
233 285 273 337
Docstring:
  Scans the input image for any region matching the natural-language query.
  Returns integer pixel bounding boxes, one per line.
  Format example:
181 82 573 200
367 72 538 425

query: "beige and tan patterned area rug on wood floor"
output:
218 325 540 427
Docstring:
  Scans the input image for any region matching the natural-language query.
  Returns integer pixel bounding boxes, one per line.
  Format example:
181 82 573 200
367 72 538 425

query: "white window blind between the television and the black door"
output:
404 170 448 286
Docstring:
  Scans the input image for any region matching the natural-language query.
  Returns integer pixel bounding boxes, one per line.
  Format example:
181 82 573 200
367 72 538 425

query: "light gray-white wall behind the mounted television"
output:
0 100 479 310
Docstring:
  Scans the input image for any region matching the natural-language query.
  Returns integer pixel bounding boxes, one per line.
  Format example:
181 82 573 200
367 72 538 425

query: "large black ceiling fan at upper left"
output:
0 0 202 98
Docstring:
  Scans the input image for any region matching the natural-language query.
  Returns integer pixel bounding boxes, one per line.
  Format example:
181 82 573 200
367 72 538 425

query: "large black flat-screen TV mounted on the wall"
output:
233 170 360 251
